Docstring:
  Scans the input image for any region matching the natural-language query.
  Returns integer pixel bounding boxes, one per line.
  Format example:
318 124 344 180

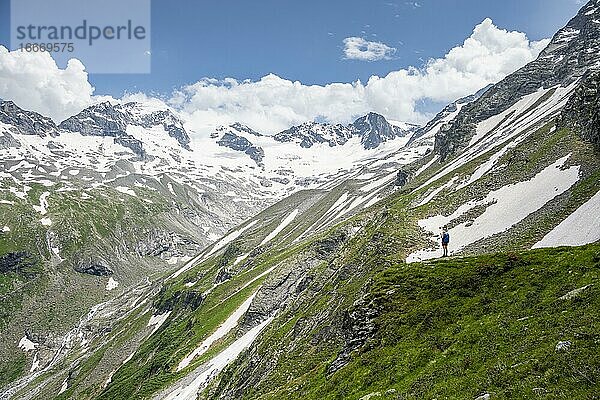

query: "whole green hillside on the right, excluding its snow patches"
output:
7 123 600 400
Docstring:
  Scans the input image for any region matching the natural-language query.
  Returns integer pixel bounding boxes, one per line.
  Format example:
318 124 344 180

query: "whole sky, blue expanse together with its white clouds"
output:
0 0 583 133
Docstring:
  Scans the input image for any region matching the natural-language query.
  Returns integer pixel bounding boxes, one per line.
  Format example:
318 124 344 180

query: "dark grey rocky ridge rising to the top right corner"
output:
435 0 600 160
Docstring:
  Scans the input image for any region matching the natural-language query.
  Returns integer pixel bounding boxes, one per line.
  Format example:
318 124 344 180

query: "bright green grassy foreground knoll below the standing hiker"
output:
262 244 600 399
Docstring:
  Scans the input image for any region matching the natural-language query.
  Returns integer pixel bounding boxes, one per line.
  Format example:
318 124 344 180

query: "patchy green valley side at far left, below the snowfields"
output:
0 179 206 394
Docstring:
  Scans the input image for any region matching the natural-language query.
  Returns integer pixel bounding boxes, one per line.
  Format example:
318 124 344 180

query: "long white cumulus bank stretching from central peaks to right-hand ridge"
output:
171 19 548 133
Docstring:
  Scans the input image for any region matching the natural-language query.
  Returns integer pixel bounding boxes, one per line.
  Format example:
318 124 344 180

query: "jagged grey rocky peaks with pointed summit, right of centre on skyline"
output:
273 113 417 150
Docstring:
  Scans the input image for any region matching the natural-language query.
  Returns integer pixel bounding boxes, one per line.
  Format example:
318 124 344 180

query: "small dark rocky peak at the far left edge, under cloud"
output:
0 100 59 138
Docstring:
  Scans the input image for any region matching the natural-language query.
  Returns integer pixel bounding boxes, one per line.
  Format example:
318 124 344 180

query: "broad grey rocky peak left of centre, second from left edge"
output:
59 102 190 159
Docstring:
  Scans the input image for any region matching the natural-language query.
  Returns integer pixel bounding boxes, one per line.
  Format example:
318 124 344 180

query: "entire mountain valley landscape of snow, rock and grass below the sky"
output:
0 0 600 400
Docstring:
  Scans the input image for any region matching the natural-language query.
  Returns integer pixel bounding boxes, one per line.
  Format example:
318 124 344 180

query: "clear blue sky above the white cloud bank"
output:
0 0 580 97
